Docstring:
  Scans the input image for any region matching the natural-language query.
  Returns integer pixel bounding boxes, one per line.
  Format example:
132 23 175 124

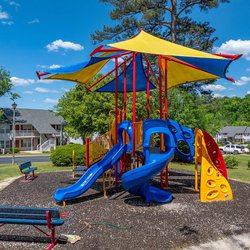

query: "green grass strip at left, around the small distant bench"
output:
0 162 72 181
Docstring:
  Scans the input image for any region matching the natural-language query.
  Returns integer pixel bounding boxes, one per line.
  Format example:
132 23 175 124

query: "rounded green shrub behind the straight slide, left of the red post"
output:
50 144 85 167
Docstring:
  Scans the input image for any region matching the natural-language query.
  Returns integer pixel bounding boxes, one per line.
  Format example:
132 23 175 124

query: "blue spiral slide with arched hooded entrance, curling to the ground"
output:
122 119 176 203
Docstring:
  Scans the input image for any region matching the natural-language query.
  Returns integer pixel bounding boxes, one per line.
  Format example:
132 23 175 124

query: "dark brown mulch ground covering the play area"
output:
0 170 250 250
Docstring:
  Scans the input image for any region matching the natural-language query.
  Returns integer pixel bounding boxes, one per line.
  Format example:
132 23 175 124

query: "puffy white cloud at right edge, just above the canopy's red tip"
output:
215 39 250 61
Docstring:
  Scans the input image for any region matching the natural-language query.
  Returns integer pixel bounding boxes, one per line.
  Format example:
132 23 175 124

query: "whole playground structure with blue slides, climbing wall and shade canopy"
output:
37 31 241 203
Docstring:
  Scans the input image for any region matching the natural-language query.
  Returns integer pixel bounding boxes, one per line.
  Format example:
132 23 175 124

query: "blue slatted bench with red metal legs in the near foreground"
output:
0 206 64 250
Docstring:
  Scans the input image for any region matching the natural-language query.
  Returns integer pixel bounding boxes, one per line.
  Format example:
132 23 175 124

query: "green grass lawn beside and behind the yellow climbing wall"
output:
169 155 250 182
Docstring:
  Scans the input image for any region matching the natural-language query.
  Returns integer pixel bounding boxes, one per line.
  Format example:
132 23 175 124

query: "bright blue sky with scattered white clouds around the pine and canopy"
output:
0 0 250 109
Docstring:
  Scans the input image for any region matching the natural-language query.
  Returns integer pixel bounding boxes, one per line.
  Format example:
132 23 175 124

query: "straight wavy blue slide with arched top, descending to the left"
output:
54 121 132 201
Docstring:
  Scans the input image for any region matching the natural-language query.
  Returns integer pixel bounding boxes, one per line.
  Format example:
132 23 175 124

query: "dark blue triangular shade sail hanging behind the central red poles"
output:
96 54 156 92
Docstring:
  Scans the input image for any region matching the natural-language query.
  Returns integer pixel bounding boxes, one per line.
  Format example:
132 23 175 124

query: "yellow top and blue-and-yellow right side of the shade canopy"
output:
109 31 240 88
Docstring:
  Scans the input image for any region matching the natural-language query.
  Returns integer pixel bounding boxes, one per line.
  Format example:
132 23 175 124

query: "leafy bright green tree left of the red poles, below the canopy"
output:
56 74 118 139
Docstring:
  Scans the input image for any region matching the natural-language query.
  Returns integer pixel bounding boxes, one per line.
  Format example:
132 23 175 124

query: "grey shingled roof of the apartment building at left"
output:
2 108 65 134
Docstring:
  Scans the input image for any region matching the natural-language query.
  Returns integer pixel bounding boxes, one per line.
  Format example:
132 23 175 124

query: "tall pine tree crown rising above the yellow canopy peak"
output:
92 0 229 47
